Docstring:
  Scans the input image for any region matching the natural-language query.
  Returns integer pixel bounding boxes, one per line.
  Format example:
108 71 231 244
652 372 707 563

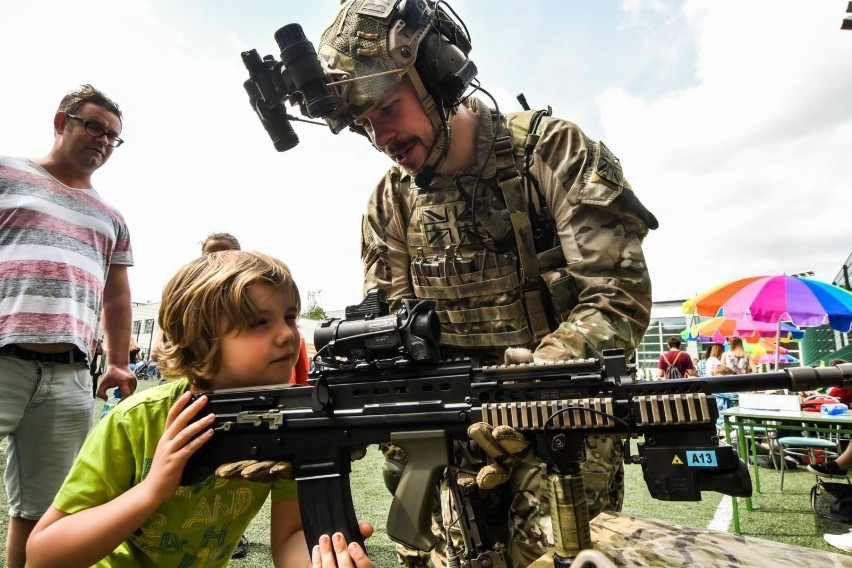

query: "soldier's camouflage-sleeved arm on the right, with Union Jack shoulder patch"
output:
531 119 651 359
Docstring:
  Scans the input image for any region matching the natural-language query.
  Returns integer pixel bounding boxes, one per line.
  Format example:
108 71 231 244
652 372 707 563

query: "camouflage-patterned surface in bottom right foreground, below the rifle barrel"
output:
524 512 852 568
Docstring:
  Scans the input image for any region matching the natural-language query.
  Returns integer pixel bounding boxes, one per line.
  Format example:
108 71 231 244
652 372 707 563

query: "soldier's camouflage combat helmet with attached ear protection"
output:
317 0 476 179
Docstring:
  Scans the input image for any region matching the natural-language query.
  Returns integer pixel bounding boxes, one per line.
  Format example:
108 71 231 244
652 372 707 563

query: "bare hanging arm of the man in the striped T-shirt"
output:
97 264 136 400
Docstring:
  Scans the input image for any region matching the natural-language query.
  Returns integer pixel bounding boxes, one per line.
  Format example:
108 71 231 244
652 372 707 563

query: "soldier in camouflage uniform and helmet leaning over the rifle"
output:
318 0 657 566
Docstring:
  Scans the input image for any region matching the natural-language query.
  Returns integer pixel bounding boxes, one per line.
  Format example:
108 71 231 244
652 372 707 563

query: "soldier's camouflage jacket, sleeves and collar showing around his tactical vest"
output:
362 99 651 359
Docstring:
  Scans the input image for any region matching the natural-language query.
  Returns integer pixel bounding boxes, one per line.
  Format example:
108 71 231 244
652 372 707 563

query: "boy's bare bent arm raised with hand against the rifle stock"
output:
27 392 216 568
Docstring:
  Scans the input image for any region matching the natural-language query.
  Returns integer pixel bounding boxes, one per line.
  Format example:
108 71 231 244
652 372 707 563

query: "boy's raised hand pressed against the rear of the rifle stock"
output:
144 392 216 501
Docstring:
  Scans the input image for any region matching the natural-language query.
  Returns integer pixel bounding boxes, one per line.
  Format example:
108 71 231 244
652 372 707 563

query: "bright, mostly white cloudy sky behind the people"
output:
0 0 852 311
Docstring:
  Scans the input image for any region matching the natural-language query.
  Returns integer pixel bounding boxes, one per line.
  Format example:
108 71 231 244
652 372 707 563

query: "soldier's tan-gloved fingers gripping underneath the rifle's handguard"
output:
467 422 536 489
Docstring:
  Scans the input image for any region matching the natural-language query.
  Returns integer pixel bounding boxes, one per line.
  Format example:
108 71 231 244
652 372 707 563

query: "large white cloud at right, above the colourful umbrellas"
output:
598 1 852 299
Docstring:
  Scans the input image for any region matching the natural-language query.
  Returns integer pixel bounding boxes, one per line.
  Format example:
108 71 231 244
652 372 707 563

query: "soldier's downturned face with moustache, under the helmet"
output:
355 79 435 174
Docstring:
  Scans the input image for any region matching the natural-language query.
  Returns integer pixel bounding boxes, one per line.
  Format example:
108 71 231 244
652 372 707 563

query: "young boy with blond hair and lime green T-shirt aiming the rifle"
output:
27 251 318 568
